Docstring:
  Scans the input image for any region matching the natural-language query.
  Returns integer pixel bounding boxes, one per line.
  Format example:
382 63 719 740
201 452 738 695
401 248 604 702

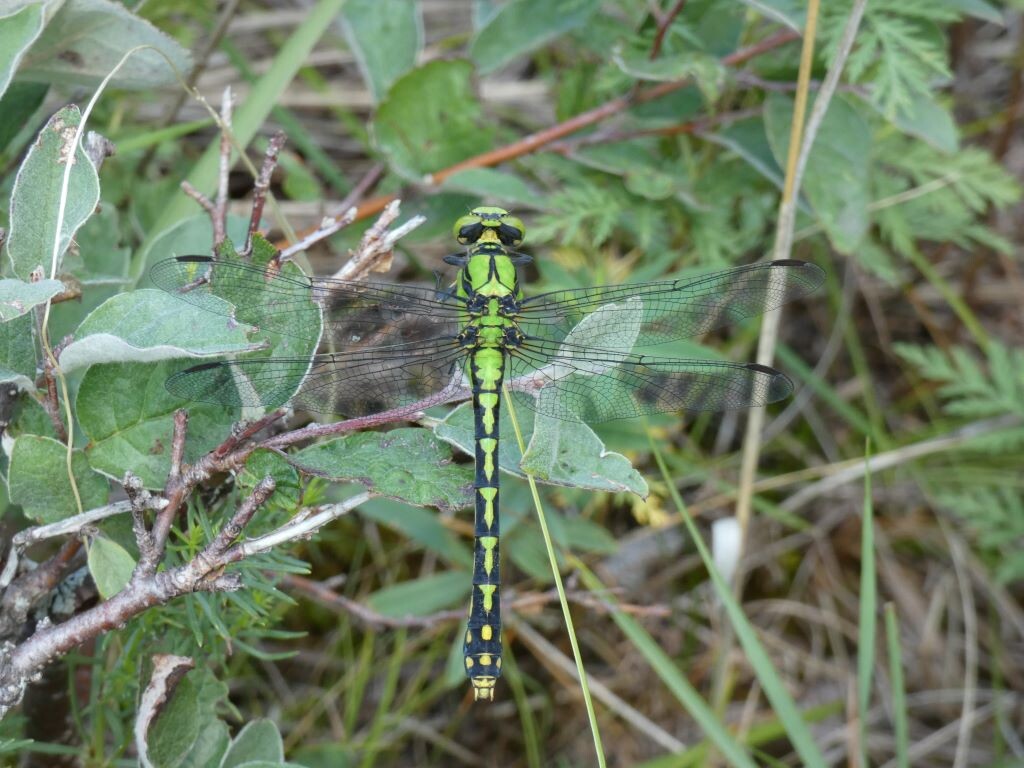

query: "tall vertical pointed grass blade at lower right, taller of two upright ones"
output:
857 446 879 768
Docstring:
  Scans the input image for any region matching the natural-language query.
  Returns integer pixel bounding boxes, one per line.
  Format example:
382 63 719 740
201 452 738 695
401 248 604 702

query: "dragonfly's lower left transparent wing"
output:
167 340 465 418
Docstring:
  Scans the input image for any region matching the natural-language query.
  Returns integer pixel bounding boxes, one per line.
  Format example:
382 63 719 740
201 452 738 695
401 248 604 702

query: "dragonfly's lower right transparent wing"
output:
509 343 793 423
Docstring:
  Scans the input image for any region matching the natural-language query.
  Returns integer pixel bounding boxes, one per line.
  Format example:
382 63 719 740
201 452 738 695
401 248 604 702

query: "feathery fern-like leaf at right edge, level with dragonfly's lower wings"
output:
895 342 1024 418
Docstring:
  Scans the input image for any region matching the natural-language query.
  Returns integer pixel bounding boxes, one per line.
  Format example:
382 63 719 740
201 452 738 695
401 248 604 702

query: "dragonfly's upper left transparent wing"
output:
150 256 462 346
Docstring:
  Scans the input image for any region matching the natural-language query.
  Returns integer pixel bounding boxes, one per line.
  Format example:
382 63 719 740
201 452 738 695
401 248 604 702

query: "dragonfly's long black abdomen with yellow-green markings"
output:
463 347 505 700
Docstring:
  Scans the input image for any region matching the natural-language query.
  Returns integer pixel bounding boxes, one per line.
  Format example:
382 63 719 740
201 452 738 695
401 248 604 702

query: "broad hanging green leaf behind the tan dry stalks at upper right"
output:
765 93 871 254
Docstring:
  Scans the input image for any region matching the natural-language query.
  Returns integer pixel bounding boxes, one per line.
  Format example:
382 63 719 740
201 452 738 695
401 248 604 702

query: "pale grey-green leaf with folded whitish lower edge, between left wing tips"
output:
59 290 257 371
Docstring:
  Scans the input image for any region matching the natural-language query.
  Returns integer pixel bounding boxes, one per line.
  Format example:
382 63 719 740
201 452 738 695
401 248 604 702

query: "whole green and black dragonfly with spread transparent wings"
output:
151 206 823 700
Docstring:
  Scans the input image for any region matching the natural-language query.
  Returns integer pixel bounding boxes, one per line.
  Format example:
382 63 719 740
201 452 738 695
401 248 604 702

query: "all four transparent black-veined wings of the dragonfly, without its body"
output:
151 256 811 422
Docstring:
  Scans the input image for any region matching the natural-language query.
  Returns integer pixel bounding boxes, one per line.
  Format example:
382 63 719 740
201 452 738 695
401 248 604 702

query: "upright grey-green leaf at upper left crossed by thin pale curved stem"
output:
7 106 99 280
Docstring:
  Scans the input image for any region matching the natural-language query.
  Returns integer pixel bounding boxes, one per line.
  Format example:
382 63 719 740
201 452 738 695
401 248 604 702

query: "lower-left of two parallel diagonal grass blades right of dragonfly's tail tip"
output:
570 558 757 768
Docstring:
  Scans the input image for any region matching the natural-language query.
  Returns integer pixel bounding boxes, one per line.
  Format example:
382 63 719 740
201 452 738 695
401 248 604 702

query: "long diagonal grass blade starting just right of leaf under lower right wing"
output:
650 439 827 767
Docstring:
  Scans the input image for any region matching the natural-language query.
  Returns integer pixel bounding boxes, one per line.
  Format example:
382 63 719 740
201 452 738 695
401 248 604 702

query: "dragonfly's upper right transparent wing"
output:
518 260 824 347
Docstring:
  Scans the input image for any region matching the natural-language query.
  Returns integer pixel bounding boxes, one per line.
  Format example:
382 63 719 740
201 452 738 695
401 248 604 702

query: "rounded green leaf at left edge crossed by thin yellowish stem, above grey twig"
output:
7 434 110 524
